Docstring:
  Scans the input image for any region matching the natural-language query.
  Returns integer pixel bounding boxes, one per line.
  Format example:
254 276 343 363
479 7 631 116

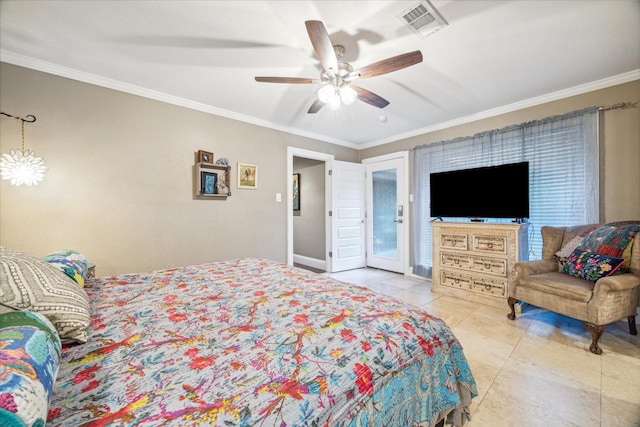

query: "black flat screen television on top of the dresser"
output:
430 162 529 221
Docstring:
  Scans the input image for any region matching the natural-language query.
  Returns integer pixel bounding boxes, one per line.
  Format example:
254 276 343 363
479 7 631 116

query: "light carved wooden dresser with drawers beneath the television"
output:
431 222 528 308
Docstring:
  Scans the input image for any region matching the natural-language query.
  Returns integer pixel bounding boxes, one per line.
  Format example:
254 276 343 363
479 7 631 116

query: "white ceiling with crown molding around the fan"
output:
0 0 640 148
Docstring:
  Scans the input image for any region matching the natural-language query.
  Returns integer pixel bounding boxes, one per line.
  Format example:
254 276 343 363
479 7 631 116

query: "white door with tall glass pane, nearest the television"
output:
366 158 408 273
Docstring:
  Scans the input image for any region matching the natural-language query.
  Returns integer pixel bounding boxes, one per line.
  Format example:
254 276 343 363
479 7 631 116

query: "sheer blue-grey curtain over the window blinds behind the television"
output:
412 107 600 278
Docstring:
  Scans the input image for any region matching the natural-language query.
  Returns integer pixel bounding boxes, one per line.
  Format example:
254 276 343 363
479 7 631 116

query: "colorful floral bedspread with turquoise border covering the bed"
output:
47 259 477 427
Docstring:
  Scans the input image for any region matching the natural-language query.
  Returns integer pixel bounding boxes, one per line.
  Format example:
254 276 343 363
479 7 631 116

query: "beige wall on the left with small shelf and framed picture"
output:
0 63 357 275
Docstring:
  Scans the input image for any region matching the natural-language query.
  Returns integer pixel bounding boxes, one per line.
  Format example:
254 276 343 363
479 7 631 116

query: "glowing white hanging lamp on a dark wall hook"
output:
0 112 47 186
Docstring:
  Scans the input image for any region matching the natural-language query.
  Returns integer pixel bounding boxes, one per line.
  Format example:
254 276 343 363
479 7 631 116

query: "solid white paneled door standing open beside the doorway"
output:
331 160 366 272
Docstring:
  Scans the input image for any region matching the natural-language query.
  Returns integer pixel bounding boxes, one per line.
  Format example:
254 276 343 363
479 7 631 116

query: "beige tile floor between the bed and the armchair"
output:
330 268 640 427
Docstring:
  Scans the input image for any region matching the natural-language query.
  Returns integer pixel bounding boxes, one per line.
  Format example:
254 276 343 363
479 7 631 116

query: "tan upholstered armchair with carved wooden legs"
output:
507 224 640 354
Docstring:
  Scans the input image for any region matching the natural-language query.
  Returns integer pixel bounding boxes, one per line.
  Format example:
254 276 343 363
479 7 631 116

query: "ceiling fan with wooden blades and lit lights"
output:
255 21 422 114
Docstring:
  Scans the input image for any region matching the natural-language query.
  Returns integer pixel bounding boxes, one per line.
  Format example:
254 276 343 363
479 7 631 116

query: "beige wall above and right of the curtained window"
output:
360 80 640 222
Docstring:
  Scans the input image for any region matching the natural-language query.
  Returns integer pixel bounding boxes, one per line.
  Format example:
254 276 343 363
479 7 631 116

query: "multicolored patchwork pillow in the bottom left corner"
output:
0 311 60 427
